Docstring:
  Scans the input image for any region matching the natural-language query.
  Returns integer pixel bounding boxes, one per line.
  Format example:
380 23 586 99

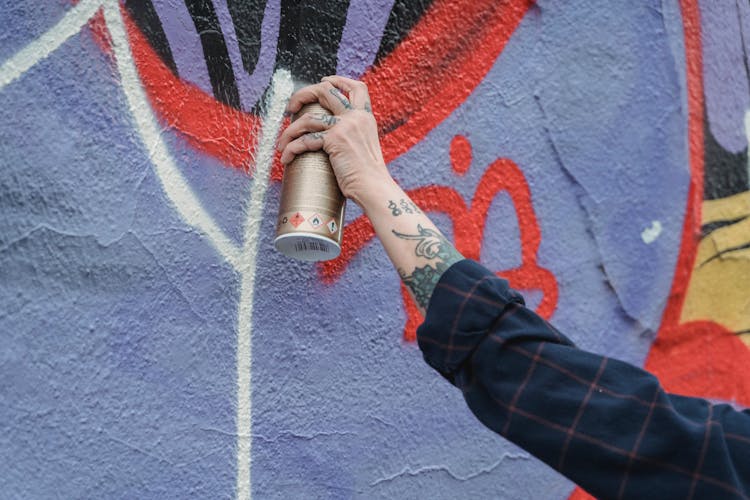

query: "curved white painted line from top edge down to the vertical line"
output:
103 0 240 269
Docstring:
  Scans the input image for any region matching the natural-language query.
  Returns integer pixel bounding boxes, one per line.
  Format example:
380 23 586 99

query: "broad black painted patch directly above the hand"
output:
277 0 349 82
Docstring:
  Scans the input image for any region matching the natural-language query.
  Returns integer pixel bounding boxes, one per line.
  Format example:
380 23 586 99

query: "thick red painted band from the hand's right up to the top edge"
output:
362 0 534 162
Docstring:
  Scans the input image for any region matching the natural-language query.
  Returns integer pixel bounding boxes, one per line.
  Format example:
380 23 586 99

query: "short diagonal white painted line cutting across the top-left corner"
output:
0 0 102 90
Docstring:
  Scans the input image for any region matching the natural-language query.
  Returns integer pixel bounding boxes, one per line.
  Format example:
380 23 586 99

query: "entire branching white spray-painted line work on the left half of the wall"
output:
0 0 293 500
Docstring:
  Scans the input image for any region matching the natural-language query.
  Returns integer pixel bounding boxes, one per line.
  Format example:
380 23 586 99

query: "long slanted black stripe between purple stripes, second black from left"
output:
185 0 240 109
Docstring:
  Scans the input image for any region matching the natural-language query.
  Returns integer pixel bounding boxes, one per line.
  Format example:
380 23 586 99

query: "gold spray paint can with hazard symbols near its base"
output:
274 103 346 261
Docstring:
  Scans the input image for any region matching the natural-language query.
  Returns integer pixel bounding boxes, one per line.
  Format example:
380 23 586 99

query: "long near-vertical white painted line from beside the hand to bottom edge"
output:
237 69 294 500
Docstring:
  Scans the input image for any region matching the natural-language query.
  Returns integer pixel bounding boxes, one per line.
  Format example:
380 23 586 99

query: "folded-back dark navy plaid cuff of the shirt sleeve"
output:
417 260 524 382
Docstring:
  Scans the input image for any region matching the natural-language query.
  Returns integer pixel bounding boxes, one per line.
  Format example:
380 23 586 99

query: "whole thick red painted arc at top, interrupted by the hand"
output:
113 0 534 174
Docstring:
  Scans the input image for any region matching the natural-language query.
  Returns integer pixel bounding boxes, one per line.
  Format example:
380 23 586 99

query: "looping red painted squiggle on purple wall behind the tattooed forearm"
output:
320 154 558 341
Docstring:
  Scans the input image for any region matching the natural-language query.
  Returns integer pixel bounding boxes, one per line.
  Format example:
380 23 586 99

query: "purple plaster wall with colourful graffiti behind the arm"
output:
0 0 750 499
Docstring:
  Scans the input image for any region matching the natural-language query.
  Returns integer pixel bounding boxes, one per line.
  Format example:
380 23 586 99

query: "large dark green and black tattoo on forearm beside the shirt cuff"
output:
392 224 463 309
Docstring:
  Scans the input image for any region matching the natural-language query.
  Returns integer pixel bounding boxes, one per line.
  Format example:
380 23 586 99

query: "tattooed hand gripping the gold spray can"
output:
278 76 393 210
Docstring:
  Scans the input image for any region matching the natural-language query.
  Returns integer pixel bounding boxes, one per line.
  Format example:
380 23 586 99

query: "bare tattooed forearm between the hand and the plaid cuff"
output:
358 178 463 314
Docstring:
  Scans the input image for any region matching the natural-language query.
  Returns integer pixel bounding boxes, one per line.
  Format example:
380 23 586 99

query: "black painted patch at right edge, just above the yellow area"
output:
703 120 750 200
